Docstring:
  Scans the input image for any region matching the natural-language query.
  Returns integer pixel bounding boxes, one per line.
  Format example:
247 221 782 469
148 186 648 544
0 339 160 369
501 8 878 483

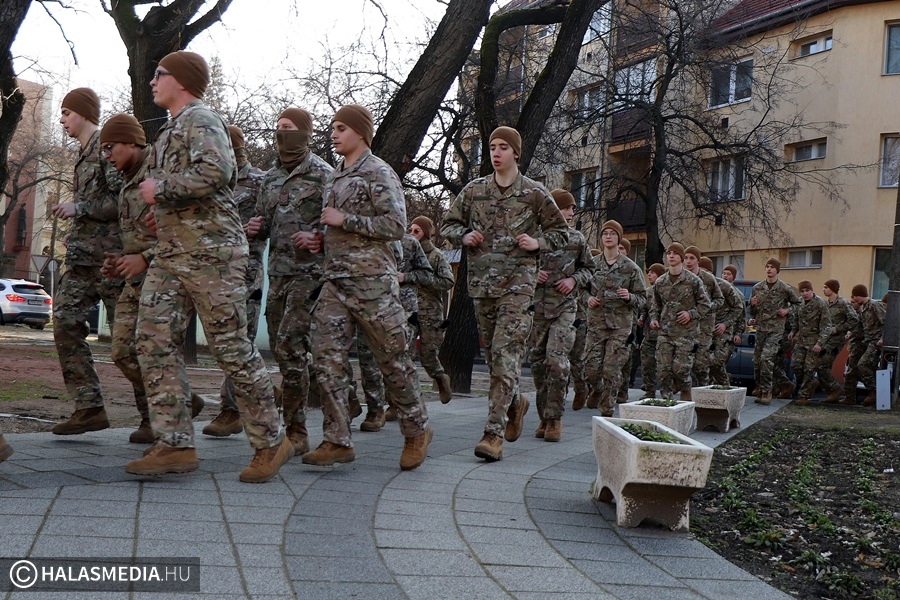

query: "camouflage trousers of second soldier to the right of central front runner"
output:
584 327 631 416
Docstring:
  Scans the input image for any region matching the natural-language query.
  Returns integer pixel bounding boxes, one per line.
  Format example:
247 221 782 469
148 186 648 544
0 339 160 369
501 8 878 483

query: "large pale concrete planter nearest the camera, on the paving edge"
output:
593 417 713 531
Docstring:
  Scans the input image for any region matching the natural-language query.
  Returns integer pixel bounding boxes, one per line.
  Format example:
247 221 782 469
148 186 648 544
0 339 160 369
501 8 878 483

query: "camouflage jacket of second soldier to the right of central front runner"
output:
588 254 647 329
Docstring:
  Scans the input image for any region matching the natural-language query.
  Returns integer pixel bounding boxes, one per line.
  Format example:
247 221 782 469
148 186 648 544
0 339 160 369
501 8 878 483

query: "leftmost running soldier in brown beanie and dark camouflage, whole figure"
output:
52 88 124 435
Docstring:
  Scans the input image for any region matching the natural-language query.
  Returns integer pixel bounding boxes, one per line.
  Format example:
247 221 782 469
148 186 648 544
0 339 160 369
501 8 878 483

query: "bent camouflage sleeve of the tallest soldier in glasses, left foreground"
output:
154 110 235 204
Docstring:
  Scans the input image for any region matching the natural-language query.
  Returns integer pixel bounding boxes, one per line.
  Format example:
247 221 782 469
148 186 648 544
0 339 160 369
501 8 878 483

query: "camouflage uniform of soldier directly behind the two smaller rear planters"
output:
650 269 712 398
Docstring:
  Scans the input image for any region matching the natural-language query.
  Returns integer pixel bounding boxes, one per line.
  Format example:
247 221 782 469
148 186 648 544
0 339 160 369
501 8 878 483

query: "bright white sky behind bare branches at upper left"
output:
12 0 445 106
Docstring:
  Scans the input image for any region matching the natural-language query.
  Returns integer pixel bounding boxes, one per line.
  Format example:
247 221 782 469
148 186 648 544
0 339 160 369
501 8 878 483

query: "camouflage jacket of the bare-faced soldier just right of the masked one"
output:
323 150 406 282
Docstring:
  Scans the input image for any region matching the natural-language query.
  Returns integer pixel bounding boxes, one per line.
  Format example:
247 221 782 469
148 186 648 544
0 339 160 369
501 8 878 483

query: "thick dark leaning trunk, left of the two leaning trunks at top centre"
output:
372 0 493 178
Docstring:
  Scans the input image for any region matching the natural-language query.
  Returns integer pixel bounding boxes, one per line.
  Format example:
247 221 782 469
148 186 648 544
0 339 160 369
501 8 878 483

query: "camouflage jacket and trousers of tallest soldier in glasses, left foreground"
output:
137 100 284 450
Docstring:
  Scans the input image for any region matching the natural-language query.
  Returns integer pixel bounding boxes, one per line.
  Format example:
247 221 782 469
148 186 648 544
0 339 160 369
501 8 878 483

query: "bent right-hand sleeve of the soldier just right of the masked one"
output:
343 165 406 241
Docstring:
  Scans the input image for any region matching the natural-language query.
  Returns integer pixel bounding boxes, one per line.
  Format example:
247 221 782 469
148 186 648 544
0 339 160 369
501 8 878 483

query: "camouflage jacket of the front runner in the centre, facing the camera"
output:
441 173 568 298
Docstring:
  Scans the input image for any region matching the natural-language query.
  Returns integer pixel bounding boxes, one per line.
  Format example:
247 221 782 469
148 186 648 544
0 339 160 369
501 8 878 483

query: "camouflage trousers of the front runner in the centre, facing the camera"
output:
473 294 532 435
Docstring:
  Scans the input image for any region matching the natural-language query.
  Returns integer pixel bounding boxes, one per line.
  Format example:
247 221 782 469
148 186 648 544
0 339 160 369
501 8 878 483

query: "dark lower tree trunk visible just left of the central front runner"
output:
439 249 478 394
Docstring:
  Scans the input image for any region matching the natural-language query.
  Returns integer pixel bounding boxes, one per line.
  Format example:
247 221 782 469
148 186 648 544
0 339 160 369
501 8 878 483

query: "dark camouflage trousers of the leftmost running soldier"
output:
53 265 124 410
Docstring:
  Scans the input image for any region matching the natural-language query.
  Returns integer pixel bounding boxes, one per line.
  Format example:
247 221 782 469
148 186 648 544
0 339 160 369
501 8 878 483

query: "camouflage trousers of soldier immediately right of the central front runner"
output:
528 312 575 420
